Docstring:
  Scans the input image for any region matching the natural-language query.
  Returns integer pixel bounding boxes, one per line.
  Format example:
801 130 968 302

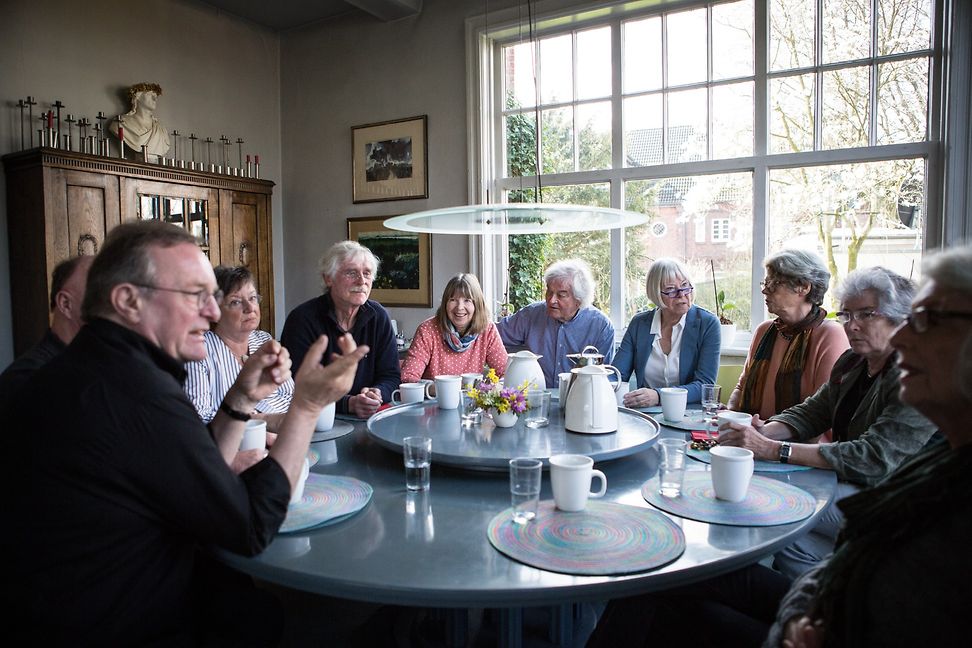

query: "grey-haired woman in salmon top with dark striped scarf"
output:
729 250 847 420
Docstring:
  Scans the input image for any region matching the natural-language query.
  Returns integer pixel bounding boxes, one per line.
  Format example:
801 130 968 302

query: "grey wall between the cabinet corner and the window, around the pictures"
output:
280 0 515 337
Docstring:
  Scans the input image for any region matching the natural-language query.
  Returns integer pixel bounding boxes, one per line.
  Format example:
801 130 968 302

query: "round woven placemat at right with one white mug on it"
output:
641 470 817 526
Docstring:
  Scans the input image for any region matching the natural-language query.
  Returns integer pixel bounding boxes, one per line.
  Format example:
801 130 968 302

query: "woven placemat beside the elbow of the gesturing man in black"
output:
280 473 374 533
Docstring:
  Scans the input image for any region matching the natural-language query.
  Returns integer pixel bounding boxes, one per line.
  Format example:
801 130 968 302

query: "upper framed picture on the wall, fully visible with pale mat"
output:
351 115 429 203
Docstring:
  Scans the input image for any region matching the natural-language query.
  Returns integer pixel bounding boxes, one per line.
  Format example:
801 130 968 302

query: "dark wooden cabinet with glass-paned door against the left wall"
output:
3 148 276 355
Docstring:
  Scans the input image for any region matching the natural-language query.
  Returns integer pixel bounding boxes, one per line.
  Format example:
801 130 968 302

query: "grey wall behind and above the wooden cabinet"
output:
0 0 285 367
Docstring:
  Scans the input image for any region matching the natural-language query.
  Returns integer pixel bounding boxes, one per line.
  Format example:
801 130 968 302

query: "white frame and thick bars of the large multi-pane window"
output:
466 0 952 331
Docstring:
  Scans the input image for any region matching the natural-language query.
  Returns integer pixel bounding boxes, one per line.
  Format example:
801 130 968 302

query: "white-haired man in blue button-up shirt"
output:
496 259 614 387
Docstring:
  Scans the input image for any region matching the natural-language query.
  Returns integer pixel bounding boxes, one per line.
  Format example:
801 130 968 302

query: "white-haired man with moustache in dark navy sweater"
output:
280 241 401 418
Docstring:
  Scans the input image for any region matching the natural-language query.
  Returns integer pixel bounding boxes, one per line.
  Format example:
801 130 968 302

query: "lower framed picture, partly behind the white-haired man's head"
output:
348 216 432 308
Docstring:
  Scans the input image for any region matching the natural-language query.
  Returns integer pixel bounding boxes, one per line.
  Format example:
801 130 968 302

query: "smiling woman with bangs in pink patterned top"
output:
402 273 506 382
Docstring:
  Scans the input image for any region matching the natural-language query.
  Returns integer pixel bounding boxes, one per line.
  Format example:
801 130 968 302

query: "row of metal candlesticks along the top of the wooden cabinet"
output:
17 96 260 178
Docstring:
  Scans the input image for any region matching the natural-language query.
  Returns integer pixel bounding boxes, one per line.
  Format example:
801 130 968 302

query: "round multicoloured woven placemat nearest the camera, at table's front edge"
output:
486 500 685 576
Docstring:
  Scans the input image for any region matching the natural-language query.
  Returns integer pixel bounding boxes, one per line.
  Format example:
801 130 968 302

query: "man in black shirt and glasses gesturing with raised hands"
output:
6 221 368 646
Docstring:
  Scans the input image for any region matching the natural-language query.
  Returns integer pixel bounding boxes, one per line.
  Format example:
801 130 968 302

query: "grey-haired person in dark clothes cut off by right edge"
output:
765 245 972 646
